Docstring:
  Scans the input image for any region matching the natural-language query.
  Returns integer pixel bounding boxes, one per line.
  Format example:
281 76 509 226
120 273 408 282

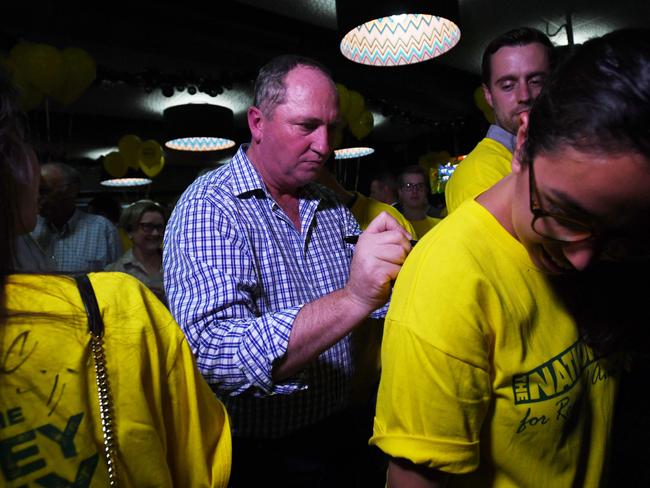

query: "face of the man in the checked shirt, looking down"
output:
248 66 338 193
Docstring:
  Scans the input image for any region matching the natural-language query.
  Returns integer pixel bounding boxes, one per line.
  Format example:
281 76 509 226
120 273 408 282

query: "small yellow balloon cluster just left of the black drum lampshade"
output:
104 134 165 178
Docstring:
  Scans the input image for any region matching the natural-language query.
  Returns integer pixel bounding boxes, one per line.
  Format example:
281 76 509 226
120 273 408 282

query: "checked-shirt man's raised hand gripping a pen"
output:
345 212 411 313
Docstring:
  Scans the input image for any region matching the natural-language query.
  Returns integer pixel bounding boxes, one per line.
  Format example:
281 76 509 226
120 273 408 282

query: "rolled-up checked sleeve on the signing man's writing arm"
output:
164 197 304 396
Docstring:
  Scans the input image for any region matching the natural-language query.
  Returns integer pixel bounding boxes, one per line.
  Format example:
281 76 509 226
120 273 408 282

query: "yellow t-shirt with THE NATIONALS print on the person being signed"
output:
371 200 619 488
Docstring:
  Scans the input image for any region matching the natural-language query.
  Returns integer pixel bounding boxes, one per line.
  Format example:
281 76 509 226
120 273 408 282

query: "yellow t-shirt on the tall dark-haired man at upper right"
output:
445 137 512 214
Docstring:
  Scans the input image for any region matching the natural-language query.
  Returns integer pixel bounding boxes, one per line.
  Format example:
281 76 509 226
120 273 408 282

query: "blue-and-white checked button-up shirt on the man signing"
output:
164 146 359 438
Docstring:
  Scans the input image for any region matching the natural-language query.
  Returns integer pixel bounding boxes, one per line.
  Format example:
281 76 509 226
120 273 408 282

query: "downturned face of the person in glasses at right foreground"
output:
512 147 650 274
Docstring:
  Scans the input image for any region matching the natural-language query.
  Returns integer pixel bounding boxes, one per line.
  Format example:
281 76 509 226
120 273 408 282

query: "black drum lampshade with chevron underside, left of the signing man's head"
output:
163 103 235 152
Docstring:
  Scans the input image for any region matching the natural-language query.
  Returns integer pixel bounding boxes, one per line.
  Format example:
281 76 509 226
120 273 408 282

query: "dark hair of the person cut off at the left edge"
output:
0 70 31 280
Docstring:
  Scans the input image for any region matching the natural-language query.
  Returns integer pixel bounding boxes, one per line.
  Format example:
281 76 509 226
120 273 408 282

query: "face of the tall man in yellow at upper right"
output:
483 43 549 134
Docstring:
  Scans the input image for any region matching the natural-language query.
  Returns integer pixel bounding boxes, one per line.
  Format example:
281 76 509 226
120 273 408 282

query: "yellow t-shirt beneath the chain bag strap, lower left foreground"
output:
0 273 231 487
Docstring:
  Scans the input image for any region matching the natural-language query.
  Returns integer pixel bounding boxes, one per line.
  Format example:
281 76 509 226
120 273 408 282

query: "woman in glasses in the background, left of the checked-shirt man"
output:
106 200 167 304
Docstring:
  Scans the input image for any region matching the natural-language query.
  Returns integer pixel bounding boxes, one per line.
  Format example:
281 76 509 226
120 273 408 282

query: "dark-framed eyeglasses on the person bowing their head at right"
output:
528 160 594 242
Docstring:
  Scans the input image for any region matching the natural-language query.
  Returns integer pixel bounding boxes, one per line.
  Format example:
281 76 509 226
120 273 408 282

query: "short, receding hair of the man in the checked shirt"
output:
253 54 331 117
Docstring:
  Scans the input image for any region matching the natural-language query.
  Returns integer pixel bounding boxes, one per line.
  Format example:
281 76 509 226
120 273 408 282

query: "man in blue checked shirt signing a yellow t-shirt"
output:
164 56 411 487
